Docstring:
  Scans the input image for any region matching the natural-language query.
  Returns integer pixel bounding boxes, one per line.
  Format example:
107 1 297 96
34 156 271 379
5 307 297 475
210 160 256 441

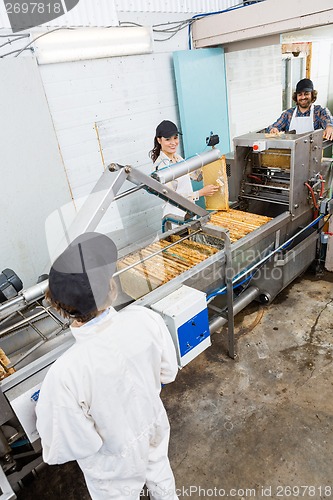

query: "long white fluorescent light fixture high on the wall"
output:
32 26 153 64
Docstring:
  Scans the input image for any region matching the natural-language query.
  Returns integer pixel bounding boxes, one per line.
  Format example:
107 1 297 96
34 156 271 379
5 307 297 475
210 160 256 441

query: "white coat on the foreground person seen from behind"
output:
36 306 178 500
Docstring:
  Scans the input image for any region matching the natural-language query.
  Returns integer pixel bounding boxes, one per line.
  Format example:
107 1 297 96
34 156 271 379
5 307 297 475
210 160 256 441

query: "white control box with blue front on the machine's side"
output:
150 285 211 368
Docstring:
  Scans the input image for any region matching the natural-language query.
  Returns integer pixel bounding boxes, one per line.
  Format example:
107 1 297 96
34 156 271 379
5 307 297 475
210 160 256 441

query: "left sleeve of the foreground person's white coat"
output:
36 367 103 465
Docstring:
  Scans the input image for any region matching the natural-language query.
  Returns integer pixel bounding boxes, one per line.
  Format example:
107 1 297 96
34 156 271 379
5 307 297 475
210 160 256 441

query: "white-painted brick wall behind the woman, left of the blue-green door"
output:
40 14 193 254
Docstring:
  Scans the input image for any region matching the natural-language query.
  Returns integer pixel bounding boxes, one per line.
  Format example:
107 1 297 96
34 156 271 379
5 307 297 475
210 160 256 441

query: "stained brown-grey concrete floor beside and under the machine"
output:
18 273 333 500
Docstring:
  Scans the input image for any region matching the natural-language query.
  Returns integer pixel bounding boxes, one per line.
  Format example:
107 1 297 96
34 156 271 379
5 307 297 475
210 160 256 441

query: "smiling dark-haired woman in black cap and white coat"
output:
149 120 219 217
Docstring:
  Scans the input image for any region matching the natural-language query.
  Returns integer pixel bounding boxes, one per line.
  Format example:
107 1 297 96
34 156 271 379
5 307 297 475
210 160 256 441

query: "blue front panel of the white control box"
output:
178 309 209 356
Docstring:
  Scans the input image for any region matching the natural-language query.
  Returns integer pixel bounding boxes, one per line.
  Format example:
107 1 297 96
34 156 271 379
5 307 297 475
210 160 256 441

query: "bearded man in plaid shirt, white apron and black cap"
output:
267 78 333 140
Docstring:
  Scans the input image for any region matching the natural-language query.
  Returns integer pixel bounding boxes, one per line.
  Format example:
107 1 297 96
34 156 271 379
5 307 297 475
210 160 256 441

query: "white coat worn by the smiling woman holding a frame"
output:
154 151 199 217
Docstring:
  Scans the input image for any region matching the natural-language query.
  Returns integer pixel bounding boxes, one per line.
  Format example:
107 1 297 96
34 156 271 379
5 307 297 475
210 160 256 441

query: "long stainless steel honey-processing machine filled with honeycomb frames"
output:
0 131 333 500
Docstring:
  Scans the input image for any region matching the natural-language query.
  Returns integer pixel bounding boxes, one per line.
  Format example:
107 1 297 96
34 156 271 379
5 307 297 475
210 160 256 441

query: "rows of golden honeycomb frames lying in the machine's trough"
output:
117 210 271 299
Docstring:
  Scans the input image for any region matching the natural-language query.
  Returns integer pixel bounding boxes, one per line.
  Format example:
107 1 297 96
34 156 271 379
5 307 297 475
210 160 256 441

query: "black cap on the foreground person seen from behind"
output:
49 232 118 317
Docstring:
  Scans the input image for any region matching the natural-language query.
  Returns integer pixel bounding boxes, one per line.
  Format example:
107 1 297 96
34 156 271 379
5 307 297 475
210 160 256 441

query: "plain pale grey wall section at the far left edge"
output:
0 58 71 286
